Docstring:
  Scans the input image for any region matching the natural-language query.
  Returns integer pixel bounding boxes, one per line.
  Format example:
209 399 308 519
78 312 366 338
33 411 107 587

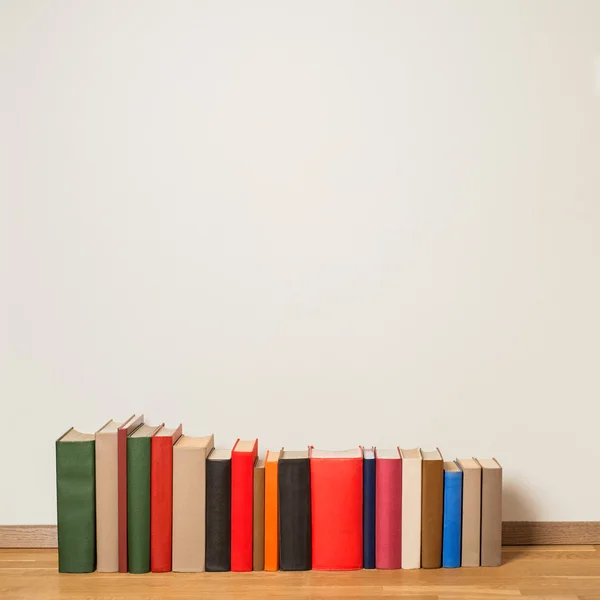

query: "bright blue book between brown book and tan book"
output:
442 462 462 569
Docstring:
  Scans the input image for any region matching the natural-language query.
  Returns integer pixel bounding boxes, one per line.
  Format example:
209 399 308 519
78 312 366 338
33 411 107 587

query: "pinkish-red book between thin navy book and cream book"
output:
375 448 402 569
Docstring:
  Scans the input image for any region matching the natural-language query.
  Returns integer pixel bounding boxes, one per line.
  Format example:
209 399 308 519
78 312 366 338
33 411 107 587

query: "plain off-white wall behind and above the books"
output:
0 0 600 524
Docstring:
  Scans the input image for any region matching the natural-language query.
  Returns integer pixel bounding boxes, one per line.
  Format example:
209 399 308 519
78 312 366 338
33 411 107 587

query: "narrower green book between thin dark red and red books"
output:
127 425 160 573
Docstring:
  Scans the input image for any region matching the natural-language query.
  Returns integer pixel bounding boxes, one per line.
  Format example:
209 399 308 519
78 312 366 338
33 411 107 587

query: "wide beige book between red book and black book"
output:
172 435 215 573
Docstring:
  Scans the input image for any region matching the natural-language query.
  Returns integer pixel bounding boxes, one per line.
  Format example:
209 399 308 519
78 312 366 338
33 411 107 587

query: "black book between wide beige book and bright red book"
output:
205 449 231 571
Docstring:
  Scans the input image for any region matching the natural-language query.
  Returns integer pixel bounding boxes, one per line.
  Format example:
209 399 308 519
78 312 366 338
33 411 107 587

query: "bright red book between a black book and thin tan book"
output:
231 440 258 571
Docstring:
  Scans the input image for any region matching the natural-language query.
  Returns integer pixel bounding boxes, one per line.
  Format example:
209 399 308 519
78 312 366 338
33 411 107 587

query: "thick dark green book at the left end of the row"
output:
56 428 96 573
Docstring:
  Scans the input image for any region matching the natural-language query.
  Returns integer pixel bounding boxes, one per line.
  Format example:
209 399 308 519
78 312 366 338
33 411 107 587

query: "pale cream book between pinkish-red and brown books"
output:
400 448 423 569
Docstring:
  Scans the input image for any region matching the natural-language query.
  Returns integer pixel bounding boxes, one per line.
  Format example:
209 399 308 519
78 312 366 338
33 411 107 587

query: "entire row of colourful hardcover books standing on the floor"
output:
56 415 502 573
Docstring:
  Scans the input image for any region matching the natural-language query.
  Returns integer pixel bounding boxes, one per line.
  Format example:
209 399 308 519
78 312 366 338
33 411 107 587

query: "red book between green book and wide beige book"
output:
150 425 182 573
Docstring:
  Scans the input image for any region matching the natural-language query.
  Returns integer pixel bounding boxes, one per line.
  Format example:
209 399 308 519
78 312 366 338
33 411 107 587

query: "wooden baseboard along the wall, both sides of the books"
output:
0 521 600 548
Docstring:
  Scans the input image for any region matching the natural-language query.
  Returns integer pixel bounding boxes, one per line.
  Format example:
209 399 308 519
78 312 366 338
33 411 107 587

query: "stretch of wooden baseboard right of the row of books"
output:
502 521 600 548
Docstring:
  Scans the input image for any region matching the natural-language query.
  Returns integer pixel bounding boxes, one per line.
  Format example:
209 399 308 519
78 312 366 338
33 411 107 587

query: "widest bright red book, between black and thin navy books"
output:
310 448 363 571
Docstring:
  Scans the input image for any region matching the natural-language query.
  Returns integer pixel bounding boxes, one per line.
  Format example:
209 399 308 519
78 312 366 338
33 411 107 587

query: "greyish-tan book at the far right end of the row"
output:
477 458 502 567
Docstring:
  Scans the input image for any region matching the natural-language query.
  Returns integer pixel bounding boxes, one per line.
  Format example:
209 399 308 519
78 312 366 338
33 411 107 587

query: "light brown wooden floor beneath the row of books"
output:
0 546 600 600
